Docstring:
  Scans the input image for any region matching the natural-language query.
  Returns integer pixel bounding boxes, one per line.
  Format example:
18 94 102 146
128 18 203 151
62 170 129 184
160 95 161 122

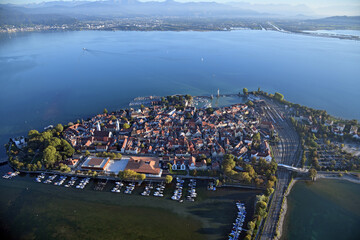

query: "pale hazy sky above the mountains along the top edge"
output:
0 0 360 15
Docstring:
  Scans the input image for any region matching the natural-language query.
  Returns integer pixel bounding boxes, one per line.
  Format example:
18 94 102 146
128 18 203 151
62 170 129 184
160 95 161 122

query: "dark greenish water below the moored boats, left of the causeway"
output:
0 165 260 240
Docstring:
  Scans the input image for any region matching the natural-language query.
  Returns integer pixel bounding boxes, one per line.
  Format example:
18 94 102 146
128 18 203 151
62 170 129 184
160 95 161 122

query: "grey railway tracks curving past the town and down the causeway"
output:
260 99 300 240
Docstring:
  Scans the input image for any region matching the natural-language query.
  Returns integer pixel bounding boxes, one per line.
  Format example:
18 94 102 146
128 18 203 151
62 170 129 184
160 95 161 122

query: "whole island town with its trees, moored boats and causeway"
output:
3 88 360 239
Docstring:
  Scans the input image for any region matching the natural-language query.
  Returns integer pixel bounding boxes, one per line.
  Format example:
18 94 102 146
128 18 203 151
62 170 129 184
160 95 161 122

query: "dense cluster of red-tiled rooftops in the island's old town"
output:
63 96 273 170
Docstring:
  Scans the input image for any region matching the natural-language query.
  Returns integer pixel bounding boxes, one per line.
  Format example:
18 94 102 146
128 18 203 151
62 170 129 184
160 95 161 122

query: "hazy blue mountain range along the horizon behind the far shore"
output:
0 0 358 24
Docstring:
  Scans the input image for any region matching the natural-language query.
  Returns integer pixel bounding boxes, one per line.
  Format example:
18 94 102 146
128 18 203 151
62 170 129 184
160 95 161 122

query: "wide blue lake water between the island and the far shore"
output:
0 30 360 156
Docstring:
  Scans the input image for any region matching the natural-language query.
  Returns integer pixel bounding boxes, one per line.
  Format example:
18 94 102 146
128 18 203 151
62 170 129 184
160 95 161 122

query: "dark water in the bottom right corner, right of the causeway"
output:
282 180 360 240
